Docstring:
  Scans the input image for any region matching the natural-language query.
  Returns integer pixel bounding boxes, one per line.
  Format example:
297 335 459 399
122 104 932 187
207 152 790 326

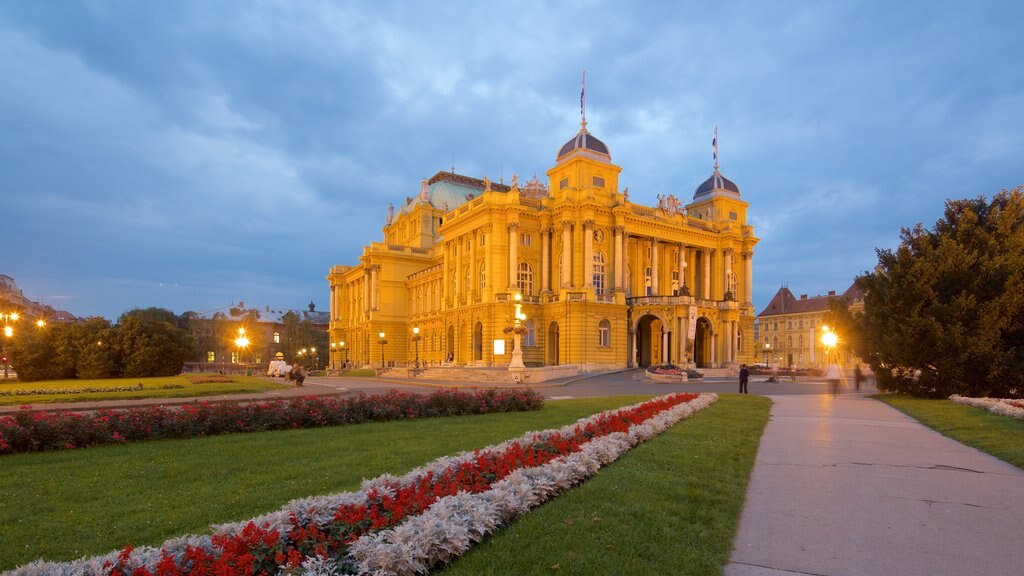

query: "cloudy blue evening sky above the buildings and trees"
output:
0 0 1024 320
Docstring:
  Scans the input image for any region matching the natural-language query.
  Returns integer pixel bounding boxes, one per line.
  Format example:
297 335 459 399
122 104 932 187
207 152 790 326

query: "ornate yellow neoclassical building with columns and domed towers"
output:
327 120 758 372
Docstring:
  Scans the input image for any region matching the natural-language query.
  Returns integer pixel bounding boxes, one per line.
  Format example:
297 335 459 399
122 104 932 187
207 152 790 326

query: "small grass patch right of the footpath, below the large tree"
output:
874 395 1024 468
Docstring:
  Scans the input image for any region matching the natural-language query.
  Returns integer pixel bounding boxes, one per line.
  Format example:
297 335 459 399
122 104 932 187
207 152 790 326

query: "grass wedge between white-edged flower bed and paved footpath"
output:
443 395 771 576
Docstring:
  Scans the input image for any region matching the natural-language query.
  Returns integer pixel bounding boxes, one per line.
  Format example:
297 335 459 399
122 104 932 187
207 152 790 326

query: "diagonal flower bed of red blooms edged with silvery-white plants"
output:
11 395 718 576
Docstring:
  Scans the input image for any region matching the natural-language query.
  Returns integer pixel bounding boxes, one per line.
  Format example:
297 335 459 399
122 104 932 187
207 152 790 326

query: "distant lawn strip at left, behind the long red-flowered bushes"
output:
0 374 290 406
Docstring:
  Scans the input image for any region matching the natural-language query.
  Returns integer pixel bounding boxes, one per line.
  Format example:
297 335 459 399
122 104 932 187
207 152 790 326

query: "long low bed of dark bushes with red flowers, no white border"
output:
0 389 544 454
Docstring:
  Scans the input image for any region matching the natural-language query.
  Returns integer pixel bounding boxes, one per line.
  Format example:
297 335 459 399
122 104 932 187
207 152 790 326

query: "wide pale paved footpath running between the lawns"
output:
725 394 1024 576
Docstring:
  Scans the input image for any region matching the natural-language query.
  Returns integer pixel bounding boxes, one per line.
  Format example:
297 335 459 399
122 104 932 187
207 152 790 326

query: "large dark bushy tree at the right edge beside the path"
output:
857 187 1024 397
